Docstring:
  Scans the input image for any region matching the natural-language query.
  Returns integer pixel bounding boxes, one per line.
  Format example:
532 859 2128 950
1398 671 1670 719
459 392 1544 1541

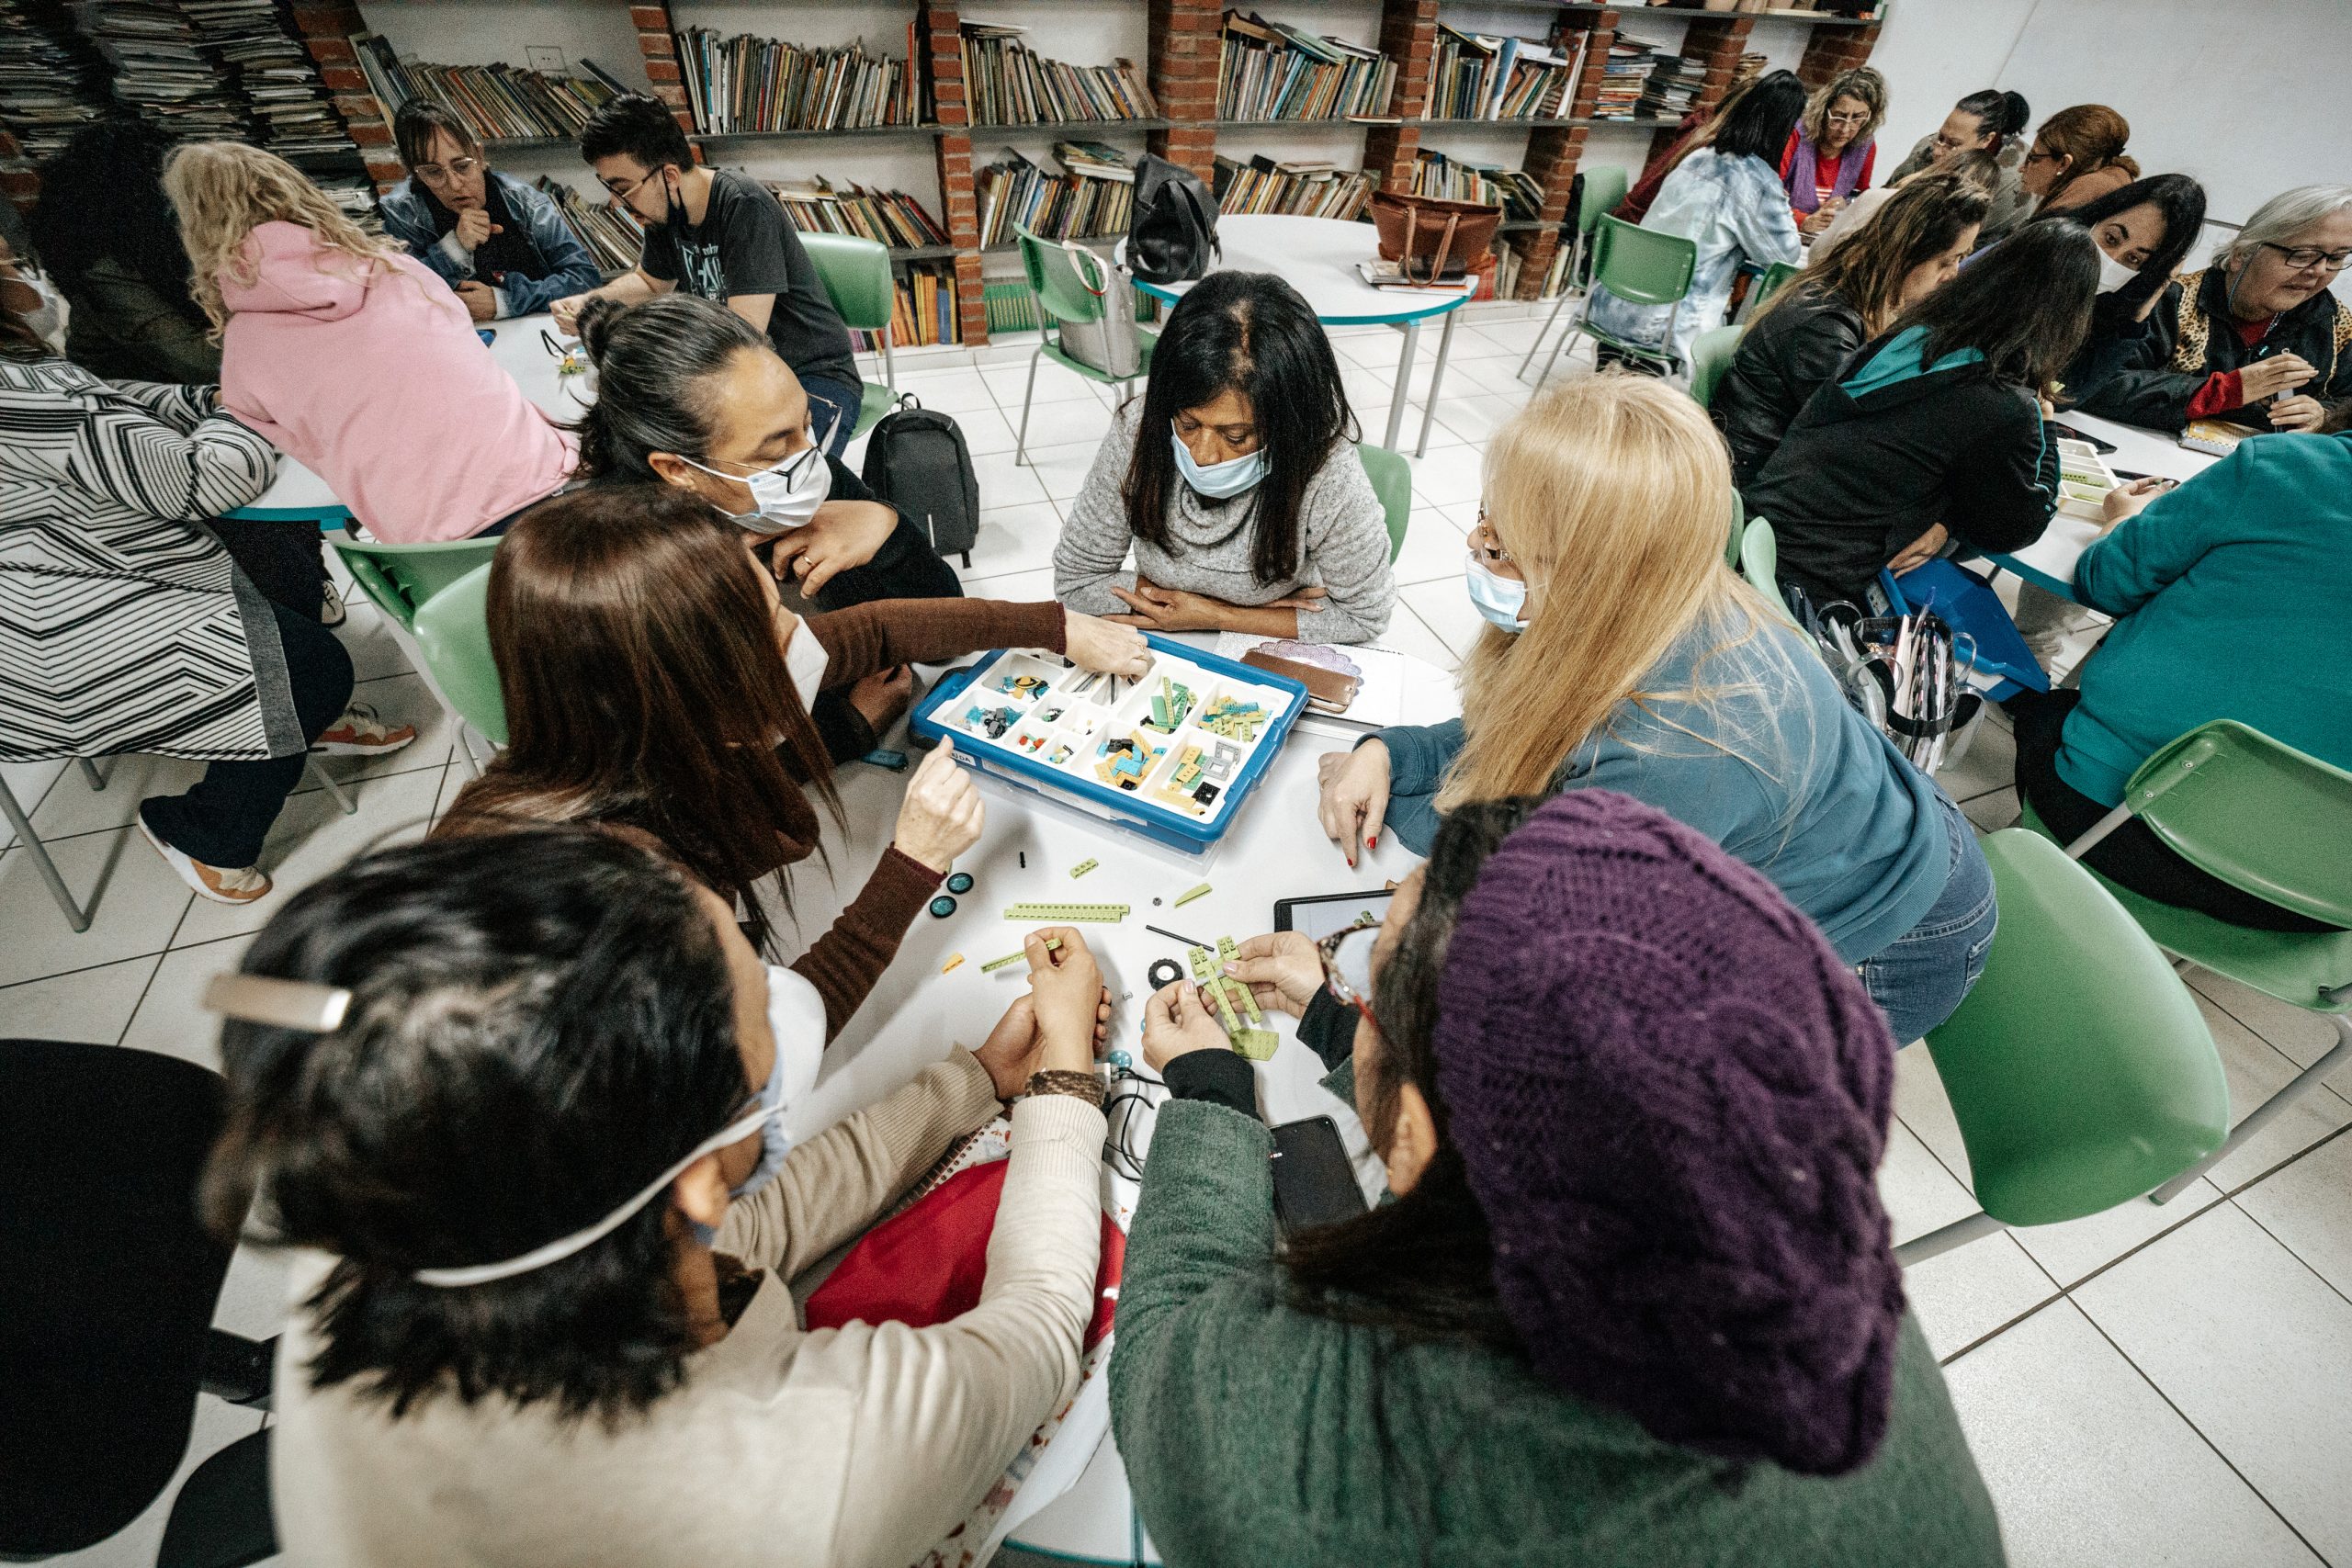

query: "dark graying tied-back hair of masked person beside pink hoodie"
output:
571 294 774 484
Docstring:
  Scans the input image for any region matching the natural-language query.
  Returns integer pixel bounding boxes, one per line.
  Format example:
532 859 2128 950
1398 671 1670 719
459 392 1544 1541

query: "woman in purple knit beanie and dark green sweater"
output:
1110 790 2004 1568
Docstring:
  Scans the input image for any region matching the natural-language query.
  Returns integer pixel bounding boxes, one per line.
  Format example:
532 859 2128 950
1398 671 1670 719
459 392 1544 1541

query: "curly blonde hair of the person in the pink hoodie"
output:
163 141 400 344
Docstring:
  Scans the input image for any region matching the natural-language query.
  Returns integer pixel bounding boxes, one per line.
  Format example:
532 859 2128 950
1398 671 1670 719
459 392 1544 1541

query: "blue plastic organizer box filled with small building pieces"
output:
912 632 1307 856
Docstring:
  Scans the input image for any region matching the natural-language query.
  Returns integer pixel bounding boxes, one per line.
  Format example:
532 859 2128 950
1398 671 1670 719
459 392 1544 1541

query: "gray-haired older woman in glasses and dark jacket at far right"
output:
2082 186 2352 430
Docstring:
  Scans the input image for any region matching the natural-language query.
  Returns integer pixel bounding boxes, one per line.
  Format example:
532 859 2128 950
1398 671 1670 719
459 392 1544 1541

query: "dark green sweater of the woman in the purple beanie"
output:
1110 1100 2004 1568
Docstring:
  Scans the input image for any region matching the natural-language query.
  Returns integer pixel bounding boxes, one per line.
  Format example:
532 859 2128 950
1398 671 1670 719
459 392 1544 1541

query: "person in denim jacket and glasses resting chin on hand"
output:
383 98 605 322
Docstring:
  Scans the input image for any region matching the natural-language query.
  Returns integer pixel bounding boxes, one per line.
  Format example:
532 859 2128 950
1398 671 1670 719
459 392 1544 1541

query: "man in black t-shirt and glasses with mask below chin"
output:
550 92 864 456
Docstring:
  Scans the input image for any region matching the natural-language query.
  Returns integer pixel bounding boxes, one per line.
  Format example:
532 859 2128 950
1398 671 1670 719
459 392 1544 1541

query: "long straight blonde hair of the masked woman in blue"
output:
1437 371 1785 811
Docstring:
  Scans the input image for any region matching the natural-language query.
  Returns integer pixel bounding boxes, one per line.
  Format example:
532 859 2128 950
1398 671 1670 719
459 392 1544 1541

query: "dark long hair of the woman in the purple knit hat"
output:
1282 795 1543 1357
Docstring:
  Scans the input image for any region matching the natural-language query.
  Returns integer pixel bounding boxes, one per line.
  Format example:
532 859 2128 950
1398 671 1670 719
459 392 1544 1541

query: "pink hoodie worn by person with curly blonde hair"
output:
221 223 579 546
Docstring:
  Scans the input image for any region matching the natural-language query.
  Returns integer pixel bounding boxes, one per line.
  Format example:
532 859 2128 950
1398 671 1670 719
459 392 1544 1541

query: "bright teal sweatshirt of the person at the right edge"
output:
2058 433 2352 807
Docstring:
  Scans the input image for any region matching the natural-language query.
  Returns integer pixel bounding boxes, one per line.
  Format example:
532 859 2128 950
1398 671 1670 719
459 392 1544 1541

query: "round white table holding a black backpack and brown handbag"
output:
1117 211 1477 456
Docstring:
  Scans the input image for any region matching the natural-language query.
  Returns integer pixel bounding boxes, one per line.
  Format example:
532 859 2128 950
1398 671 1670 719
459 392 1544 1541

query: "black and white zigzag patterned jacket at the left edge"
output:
0 357 303 761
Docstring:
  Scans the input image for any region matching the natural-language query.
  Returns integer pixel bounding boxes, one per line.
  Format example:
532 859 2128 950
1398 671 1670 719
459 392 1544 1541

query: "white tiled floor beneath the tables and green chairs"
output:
0 324 2352 1568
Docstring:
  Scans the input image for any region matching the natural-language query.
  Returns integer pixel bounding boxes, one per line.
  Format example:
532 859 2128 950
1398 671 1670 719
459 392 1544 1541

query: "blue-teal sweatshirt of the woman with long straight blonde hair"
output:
1378 606 1957 964
